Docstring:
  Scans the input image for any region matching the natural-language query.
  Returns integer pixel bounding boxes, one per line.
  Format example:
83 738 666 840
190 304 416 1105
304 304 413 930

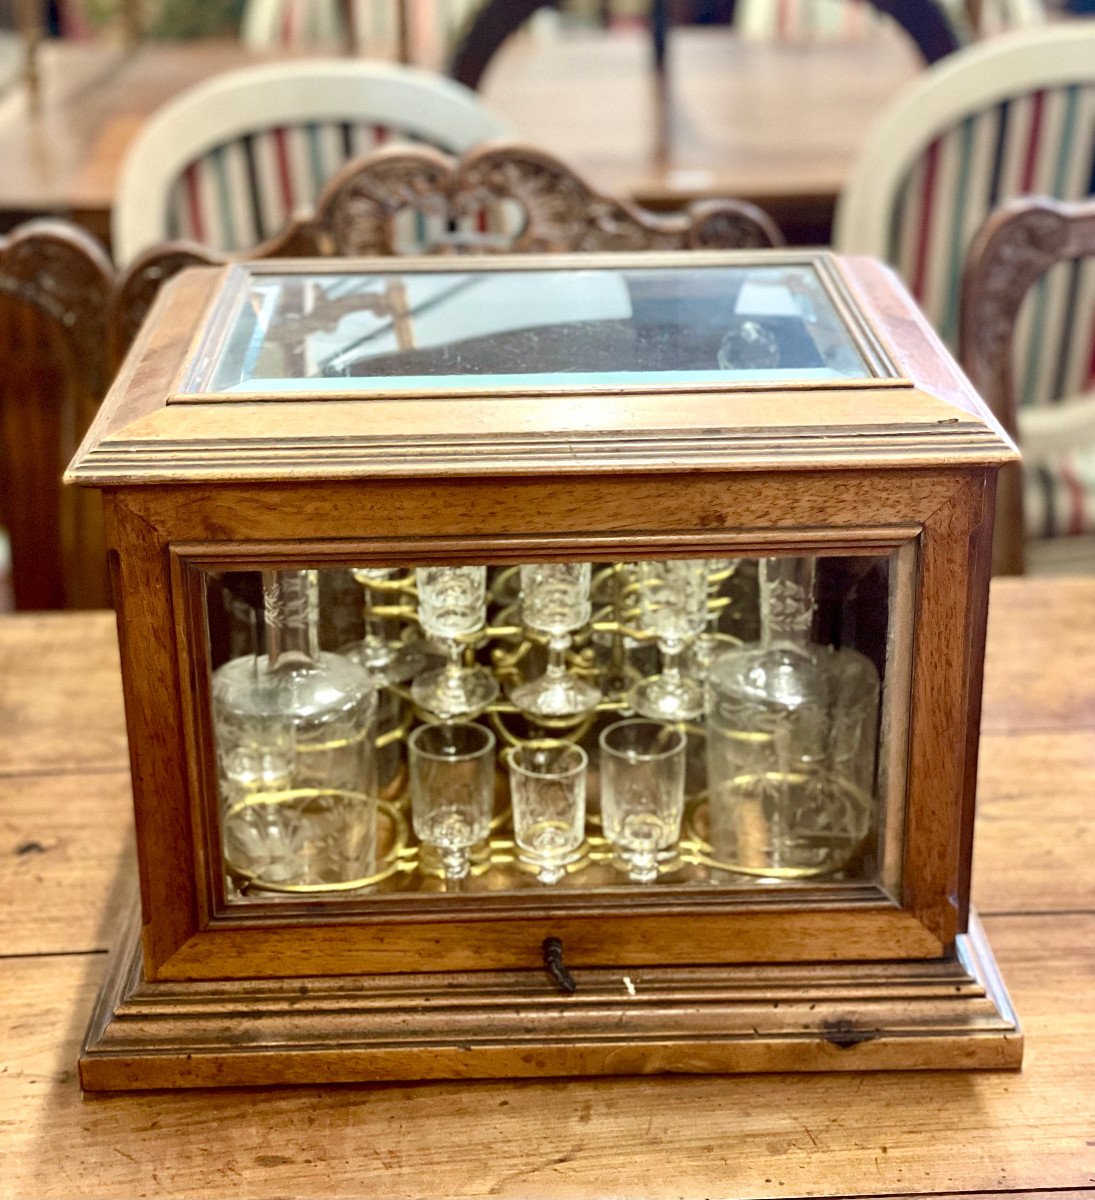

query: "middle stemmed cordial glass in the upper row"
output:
509 563 600 719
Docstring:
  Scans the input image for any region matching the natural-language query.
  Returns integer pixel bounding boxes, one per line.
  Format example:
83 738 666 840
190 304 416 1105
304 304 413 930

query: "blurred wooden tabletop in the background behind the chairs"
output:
0 29 920 246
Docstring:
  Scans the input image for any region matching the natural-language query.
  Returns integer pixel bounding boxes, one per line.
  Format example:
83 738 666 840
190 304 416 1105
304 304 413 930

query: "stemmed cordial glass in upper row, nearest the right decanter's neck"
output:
630 558 707 721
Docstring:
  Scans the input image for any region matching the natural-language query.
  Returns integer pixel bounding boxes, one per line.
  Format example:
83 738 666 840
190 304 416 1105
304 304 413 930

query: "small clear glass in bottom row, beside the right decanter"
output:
600 719 687 883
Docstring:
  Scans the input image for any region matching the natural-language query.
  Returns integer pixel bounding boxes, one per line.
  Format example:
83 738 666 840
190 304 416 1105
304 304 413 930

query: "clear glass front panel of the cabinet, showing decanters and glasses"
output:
204 553 908 902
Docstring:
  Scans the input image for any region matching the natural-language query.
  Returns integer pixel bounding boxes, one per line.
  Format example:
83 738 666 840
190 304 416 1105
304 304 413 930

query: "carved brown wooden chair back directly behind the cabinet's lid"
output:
112 143 783 354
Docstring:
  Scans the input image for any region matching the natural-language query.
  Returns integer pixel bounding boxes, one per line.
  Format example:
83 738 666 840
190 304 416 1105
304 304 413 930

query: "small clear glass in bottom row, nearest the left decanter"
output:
407 721 495 882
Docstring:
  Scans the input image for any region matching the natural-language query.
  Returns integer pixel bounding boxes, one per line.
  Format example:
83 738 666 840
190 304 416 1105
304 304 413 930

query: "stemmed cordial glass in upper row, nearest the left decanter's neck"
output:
411 566 498 720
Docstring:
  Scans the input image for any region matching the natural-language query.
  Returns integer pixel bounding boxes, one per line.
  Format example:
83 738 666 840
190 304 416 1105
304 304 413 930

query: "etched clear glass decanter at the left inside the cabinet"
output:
213 570 377 886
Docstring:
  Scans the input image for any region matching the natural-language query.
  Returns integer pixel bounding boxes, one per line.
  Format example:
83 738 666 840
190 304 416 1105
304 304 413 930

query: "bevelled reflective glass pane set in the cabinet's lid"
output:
196 263 870 395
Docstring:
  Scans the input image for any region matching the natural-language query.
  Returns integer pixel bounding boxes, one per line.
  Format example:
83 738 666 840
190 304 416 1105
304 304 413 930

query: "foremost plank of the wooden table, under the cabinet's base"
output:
0 914 1095 1198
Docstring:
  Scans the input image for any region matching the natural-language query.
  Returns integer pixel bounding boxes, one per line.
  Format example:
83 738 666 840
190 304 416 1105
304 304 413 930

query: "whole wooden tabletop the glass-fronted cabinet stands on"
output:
0 580 1095 1198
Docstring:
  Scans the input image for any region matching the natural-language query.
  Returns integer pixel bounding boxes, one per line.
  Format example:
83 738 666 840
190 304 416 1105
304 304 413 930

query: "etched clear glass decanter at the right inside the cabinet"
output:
707 558 879 878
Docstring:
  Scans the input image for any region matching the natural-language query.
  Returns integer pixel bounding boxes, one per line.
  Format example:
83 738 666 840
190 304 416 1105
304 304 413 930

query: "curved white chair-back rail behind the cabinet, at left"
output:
112 60 510 265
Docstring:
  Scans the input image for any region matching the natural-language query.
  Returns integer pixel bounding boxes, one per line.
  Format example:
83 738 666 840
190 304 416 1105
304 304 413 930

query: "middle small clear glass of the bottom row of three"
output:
505 738 590 883
